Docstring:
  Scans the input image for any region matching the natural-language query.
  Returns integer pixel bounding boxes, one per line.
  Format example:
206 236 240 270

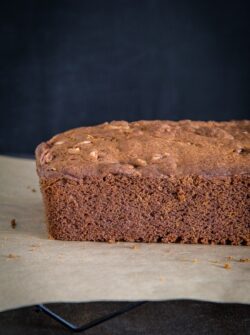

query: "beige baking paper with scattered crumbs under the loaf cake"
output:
0 157 250 311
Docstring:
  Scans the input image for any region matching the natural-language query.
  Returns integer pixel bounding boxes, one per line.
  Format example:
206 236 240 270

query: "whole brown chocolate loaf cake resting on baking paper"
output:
36 120 250 245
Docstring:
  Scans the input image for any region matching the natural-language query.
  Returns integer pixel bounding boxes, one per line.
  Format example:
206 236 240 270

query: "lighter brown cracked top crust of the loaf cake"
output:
36 120 250 178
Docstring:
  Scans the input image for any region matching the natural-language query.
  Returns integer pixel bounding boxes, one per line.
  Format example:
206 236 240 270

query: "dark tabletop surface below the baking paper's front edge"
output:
0 300 250 335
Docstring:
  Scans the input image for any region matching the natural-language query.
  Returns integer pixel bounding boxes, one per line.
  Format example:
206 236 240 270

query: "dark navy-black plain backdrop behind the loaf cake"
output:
0 0 250 153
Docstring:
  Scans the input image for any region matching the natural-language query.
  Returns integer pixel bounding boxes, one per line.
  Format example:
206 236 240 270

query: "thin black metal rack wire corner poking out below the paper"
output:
36 301 147 333
